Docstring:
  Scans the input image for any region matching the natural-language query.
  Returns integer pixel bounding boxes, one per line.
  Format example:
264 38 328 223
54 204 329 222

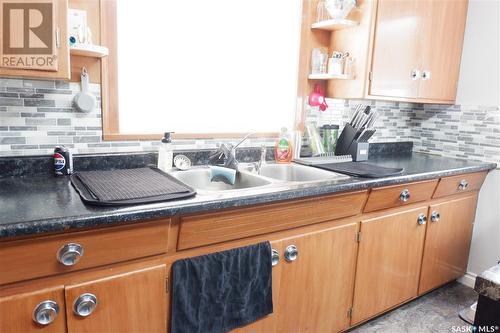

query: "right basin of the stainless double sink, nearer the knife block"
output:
259 163 349 182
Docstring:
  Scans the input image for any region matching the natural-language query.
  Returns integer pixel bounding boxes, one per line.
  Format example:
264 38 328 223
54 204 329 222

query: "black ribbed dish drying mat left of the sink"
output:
71 168 196 206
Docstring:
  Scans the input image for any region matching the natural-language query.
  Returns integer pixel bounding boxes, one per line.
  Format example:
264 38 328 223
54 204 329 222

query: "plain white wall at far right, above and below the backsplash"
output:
457 0 500 286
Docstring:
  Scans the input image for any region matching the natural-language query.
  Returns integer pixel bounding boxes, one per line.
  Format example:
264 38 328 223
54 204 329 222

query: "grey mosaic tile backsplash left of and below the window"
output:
0 78 274 156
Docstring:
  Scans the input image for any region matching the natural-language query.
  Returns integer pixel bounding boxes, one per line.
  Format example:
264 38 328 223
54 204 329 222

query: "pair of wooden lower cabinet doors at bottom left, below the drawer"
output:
0 265 168 333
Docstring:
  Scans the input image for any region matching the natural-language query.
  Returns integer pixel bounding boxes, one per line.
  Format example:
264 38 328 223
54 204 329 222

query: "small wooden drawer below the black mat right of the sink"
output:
365 179 438 212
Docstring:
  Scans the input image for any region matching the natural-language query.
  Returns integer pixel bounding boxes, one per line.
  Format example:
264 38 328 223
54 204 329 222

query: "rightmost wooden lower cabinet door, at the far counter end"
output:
419 195 477 294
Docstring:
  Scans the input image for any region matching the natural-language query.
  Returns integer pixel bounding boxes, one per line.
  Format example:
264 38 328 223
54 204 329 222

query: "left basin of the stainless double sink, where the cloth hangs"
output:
171 168 271 191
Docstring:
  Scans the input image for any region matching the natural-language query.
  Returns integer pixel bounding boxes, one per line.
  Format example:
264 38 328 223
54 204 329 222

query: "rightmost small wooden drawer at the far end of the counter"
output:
434 171 487 198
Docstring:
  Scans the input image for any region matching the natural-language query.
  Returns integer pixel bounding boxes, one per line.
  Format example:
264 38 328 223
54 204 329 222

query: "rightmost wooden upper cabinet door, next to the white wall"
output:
418 0 467 101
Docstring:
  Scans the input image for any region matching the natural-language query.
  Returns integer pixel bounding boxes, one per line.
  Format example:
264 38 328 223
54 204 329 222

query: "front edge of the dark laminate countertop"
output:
0 156 496 240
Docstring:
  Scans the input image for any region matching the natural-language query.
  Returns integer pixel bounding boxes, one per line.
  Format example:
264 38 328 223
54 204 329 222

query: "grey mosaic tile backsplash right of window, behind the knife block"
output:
306 99 500 163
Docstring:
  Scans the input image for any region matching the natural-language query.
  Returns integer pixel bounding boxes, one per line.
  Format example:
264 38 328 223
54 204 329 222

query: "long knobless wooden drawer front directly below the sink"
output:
177 191 367 250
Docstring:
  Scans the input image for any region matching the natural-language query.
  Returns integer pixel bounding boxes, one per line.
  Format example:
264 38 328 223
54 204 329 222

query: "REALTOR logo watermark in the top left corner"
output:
1 3 57 70
